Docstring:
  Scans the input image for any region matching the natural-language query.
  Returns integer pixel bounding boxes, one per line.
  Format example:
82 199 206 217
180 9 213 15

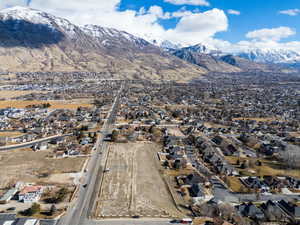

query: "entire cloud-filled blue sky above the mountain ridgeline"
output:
0 0 300 52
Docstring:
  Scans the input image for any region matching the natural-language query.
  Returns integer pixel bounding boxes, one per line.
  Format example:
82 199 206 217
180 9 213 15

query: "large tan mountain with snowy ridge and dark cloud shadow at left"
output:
0 7 206 80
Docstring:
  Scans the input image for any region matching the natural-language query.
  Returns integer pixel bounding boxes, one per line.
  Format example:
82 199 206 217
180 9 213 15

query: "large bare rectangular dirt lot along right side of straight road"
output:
97 143 178 217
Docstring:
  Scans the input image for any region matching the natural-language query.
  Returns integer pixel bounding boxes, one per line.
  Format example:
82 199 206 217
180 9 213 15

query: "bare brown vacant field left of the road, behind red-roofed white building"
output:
0 149 86 188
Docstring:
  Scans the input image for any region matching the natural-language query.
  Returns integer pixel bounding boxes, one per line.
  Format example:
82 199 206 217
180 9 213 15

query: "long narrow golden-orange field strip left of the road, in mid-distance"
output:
0 100 92 109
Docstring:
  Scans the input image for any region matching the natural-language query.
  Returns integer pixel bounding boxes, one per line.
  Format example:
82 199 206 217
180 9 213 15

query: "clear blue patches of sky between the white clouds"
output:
119 0 300 42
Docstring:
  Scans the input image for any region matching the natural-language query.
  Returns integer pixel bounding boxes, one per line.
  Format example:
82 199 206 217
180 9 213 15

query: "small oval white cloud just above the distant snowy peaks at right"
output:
246 27 296 41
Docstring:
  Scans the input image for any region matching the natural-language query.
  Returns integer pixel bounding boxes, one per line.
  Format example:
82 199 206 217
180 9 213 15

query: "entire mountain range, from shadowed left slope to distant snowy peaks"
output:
0 7 300 81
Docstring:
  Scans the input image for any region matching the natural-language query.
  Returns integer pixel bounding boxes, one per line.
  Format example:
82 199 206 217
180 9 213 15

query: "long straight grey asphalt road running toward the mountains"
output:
58 87 123 225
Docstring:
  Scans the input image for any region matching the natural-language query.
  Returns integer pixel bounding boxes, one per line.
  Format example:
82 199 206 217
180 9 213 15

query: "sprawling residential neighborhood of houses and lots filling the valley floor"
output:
0 73 300 225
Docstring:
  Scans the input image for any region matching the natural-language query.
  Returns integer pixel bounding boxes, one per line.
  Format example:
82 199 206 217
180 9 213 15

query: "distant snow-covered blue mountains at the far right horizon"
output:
235 49 300 63
